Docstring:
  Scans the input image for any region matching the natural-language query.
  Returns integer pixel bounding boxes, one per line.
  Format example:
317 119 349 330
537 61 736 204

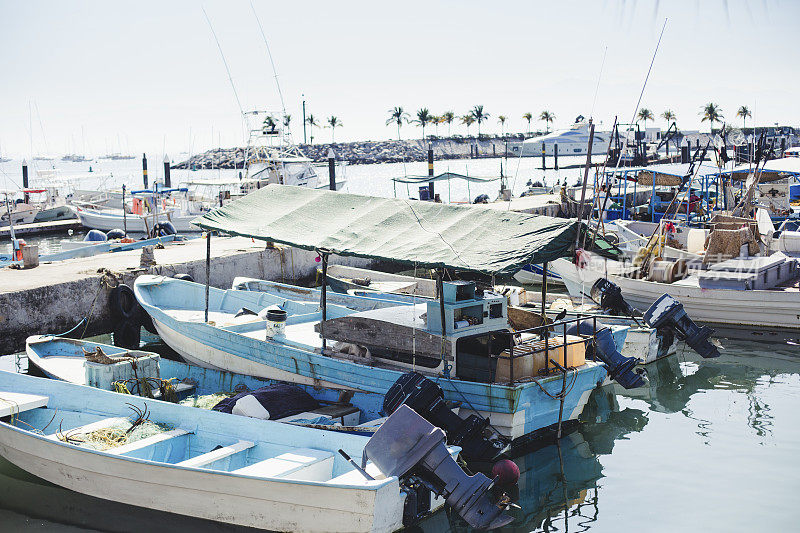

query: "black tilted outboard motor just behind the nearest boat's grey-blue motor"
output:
383 372 505 462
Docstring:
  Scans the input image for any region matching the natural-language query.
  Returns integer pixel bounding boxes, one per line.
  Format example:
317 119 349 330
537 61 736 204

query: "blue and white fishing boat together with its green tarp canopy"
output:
134 186 648 439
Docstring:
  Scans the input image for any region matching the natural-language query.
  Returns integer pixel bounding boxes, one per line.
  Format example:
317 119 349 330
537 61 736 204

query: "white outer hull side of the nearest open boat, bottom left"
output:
0 420 403 532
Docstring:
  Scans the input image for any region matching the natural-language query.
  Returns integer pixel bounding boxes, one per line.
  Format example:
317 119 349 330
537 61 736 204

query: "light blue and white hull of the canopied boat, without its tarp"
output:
134 276 628 440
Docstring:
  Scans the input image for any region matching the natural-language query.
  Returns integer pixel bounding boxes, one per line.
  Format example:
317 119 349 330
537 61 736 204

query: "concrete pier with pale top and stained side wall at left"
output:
0 237 370 354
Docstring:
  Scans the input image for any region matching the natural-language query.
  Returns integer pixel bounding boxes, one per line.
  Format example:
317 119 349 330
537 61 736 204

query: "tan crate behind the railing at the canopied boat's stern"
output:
495 335 586 383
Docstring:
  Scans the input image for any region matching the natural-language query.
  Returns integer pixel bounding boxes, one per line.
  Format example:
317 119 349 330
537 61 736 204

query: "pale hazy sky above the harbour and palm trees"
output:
0 0 800 156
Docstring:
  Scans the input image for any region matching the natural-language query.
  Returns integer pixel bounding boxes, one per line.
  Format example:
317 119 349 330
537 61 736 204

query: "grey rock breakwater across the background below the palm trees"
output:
172 136 522 169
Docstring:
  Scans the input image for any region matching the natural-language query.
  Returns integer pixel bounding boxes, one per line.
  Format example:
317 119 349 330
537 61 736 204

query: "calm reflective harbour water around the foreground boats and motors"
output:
0 340 800 533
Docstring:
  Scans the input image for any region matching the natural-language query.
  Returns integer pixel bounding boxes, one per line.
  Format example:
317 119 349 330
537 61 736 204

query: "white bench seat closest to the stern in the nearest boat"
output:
233 448 333 481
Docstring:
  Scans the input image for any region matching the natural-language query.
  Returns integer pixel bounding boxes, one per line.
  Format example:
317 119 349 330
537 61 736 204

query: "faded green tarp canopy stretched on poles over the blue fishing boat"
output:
194 185 579 274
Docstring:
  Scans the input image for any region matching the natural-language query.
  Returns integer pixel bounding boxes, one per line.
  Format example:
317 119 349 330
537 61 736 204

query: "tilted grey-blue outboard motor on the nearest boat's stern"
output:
361 405 513 529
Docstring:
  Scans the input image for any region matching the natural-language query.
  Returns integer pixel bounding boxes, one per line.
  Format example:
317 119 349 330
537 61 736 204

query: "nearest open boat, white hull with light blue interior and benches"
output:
0 372 446 532
